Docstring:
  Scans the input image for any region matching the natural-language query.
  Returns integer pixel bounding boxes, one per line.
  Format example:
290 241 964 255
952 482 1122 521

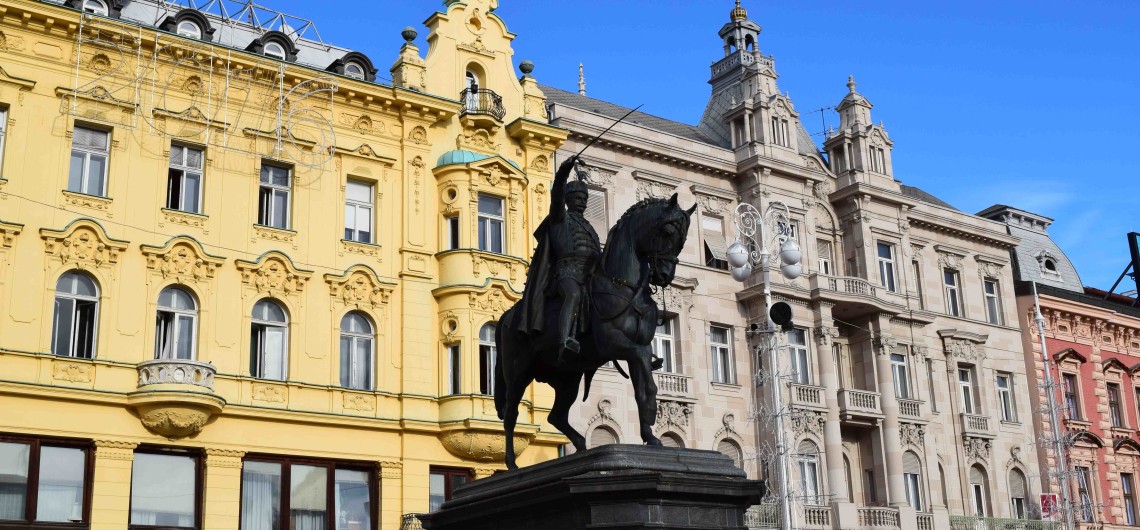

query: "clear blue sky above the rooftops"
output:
269 0 1140 288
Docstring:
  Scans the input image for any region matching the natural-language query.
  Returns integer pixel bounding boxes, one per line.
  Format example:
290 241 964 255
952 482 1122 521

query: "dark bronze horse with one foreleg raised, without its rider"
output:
495 194 697 470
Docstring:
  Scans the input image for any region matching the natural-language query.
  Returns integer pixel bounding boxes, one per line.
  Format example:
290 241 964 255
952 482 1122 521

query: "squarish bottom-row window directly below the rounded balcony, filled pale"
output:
130 451 202 528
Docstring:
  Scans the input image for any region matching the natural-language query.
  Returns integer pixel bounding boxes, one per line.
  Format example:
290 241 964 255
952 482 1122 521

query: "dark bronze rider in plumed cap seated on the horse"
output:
546 156 602 361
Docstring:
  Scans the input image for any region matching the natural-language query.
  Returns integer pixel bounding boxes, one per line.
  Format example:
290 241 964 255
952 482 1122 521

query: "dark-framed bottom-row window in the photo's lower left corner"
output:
0 437 91 528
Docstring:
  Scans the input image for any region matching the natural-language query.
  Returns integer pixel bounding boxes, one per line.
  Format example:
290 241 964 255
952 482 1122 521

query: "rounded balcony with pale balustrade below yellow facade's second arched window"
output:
128 359 226 438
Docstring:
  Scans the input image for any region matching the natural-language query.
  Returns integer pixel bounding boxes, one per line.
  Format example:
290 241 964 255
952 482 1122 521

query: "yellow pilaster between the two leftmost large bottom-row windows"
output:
91 440 138 530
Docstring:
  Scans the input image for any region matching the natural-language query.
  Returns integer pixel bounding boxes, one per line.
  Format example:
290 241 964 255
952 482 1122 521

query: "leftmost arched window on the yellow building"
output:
51 272 99 359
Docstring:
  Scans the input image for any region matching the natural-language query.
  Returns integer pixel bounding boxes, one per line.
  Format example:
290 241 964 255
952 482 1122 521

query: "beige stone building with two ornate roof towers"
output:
543 6 1040 529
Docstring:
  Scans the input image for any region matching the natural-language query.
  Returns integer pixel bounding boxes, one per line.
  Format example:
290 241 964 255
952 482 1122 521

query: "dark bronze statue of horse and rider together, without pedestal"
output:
494 151 697 470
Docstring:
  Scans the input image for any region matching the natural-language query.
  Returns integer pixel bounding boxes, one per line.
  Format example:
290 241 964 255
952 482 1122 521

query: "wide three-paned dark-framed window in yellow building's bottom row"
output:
241 456 377 530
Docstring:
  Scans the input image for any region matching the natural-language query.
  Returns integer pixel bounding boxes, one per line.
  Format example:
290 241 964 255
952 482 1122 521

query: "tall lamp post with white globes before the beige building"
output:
725 201 804 530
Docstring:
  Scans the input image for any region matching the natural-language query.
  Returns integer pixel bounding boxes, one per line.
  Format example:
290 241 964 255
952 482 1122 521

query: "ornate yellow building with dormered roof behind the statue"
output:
0 0 567 530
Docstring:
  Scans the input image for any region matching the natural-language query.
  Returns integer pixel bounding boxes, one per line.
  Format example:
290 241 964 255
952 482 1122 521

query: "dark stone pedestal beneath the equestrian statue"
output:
423 445 764 530
